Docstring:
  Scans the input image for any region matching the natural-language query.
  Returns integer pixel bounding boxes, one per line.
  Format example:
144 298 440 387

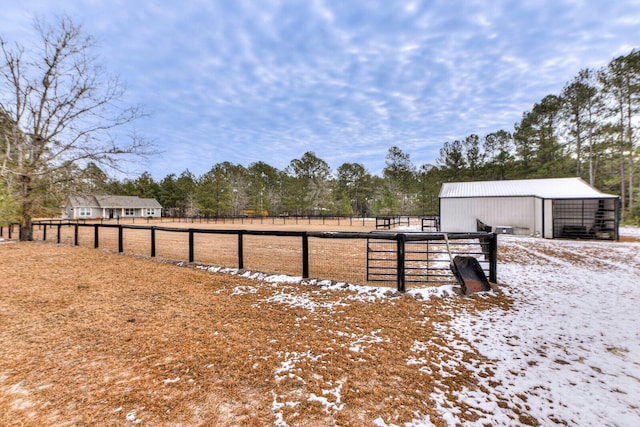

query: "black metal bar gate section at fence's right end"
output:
367 232 497 288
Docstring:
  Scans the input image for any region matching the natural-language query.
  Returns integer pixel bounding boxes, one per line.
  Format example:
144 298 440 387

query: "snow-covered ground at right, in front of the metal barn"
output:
436 228 640 426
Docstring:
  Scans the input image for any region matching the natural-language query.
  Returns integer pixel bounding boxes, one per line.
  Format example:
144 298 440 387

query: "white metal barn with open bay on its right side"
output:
439 178 619 240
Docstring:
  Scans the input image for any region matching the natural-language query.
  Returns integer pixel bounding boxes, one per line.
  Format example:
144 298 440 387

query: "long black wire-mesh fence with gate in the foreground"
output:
18 221 497 292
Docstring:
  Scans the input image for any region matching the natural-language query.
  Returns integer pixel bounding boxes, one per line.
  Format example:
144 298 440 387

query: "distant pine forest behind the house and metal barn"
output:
5 49 640 221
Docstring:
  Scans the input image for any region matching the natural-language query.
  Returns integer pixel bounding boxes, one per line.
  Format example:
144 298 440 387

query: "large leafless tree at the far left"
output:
0 17 151 240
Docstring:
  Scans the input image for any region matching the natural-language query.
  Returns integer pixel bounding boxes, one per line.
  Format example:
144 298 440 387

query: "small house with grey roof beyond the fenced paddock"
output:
63 196 162 219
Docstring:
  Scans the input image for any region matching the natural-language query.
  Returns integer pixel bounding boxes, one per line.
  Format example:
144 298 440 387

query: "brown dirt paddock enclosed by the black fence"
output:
26 218 495 287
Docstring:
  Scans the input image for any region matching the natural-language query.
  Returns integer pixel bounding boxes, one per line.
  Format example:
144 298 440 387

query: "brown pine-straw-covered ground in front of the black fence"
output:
0 242 510 426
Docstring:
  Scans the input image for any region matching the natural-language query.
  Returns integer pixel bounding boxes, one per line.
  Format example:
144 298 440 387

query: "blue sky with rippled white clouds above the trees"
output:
0 0 640 180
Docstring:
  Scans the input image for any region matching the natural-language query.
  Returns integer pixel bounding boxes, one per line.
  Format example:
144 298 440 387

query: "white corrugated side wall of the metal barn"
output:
440 197 542 234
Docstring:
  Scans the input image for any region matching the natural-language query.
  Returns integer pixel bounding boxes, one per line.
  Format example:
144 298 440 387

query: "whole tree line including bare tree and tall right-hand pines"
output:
0 18 640 240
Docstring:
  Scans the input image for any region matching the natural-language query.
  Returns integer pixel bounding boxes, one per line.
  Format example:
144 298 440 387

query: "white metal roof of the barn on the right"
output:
439 178 618 199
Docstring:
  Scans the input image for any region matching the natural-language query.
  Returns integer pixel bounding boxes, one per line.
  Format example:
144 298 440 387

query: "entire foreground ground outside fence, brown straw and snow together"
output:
0 224 640 426
